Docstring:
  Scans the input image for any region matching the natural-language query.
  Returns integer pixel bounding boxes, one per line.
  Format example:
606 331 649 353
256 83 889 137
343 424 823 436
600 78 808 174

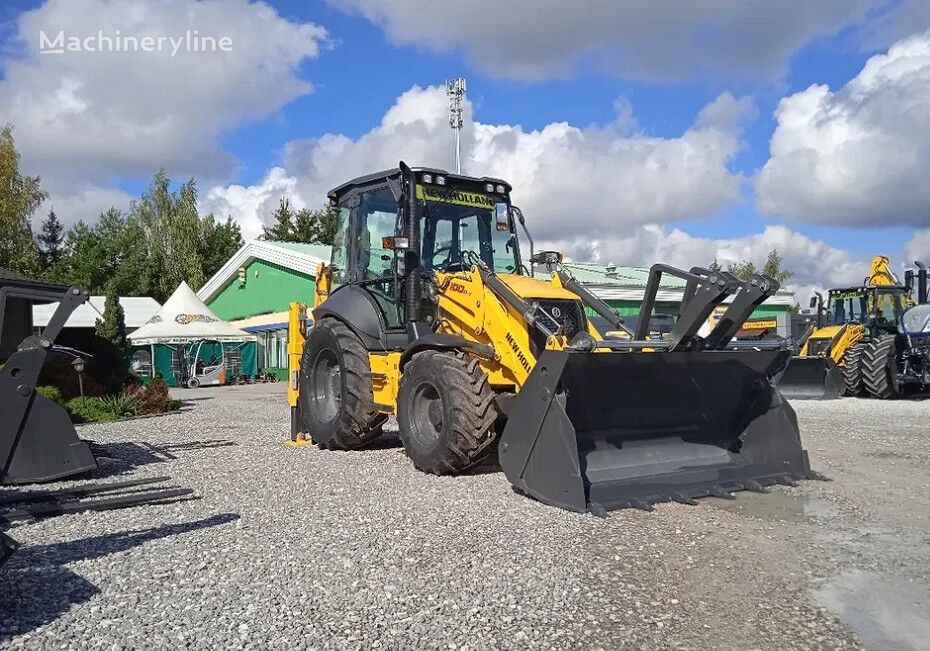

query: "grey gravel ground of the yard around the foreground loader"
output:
0 385 930 649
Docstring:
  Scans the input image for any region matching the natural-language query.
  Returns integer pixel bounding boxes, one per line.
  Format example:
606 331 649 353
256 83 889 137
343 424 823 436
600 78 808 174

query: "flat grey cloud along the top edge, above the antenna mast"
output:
329 0 886 80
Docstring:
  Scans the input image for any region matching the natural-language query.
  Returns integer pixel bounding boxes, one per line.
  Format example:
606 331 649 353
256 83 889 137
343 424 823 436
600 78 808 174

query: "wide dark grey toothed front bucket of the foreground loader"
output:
499 350 817 513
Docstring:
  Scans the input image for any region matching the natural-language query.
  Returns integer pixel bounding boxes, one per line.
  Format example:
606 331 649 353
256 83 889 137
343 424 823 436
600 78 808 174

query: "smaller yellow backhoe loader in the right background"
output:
779 255 909 399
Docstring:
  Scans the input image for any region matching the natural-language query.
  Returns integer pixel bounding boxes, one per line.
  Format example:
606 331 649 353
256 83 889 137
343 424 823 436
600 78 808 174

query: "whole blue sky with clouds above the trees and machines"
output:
0 0 930 291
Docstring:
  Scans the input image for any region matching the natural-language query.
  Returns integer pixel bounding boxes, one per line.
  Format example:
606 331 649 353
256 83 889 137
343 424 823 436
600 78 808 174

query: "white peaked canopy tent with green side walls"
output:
129 282 257 386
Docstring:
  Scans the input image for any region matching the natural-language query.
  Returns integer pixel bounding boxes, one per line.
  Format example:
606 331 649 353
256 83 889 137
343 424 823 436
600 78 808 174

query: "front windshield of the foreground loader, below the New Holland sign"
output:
421 200 520 273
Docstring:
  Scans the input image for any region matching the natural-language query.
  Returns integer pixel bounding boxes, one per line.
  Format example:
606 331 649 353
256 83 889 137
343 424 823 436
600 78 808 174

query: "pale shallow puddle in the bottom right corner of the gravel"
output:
814 570 930 650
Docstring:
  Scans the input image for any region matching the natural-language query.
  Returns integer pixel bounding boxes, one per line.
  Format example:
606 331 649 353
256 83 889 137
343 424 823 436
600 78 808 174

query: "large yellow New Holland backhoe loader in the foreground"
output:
289 163 817 513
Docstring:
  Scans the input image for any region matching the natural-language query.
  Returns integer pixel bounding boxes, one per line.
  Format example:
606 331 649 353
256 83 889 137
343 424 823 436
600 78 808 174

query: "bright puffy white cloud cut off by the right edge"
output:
756 32 930 226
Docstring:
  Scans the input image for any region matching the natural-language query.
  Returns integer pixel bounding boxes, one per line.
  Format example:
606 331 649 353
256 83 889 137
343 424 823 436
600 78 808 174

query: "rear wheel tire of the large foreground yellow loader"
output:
299 319 387 450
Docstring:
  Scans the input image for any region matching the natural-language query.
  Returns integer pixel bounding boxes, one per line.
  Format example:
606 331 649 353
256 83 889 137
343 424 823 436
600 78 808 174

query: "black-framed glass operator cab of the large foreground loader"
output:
320 164 525 338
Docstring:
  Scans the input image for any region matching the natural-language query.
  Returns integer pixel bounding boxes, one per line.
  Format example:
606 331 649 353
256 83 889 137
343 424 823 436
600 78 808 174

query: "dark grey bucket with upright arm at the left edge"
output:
0 287 97 484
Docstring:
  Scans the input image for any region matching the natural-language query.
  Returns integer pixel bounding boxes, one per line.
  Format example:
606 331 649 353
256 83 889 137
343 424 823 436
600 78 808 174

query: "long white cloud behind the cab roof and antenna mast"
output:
209 87 754 238
